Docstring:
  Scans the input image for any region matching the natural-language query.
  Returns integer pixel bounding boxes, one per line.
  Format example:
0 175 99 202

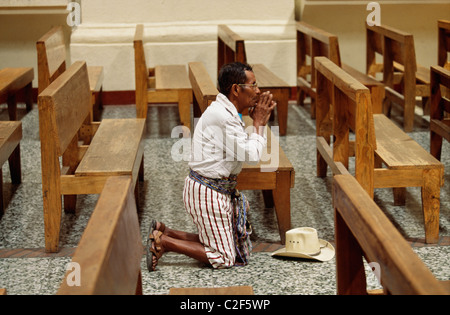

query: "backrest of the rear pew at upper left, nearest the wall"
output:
36 26 67 93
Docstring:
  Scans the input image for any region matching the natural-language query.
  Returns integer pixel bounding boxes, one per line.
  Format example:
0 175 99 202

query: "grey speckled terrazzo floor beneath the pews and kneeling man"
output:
0 103 450 295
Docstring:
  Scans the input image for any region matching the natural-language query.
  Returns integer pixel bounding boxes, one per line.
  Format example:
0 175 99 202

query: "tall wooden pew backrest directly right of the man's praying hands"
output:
315 57 376 195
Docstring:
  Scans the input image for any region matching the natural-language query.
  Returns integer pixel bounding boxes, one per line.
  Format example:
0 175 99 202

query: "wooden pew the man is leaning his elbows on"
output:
189 62 295 244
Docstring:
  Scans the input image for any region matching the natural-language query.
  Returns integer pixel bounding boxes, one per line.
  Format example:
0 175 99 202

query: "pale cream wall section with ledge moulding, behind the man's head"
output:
71 0 295 91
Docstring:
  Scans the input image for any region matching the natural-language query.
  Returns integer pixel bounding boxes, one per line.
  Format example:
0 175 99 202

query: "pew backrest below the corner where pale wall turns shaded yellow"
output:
297 22 341 87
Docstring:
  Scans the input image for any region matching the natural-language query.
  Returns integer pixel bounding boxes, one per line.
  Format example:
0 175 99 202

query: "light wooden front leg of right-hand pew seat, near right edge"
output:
422 169 441 244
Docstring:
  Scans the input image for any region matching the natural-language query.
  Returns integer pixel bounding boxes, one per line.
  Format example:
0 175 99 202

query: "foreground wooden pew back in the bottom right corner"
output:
333 174 450 295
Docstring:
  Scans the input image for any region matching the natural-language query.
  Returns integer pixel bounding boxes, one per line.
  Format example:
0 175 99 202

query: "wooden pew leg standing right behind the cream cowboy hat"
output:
273 172 291 244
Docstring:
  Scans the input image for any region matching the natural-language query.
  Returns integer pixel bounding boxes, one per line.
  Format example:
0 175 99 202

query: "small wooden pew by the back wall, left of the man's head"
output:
134 24 192 129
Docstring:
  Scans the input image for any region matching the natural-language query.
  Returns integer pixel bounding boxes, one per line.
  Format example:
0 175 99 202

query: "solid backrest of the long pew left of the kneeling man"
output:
38 61 91 156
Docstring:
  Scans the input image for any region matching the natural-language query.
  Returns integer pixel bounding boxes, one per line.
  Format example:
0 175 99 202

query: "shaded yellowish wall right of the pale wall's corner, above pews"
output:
297 0 450 71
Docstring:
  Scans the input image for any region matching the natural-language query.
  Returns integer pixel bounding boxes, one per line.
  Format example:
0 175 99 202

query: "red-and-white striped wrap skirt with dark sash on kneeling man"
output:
183 170 252 269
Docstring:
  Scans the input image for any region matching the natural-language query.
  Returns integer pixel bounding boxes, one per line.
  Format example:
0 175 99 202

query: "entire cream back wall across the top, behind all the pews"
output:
0 0 450 95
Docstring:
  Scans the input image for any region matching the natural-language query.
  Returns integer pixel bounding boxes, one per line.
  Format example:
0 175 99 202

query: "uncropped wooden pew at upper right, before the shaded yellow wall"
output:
366 24 430 132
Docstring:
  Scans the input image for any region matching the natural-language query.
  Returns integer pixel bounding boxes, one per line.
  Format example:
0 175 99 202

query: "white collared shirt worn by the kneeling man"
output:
189 94 267 178
